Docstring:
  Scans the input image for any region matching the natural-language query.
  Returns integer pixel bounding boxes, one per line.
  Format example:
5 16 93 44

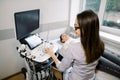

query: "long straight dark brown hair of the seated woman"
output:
77 10 104 64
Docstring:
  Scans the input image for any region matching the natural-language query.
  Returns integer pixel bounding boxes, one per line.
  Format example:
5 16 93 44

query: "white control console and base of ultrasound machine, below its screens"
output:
17 37 58 80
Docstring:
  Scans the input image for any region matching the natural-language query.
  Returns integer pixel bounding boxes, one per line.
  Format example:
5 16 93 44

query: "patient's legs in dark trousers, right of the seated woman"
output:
97 50 120 78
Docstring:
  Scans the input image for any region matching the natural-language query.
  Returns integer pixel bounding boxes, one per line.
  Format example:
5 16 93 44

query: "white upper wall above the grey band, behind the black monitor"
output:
0 0 69 29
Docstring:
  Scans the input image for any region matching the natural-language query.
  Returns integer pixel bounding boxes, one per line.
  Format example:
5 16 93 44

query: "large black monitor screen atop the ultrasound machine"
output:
14 9 40 40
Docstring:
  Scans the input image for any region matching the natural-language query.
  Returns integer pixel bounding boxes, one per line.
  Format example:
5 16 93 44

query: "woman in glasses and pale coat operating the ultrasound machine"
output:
45 10 104 80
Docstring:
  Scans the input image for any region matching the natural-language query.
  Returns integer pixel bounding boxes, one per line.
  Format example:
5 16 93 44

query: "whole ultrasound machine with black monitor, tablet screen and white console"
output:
14 9 58 80
